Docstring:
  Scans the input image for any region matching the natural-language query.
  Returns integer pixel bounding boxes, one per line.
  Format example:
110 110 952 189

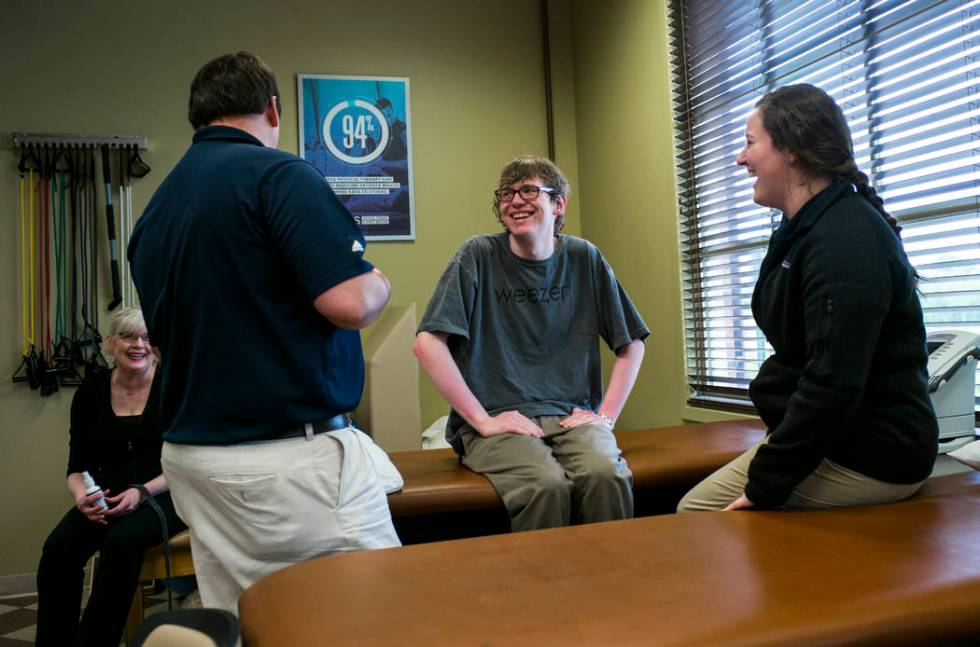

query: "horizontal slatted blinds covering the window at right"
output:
670 0 980 405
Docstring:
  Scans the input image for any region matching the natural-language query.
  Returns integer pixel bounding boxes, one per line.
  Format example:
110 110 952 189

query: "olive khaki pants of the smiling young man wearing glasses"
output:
462 416 633 532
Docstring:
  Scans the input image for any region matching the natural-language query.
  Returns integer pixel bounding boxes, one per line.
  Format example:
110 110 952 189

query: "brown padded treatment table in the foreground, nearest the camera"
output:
239 473 980 647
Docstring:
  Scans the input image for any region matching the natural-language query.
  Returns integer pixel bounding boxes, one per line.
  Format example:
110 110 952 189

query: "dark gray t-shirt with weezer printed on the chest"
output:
419 232 650 451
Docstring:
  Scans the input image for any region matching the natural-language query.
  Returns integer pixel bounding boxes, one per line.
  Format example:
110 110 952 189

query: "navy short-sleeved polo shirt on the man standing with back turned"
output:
128 126 372 445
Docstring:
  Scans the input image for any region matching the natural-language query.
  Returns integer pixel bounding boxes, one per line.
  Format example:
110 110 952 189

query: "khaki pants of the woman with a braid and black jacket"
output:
677 437 925 512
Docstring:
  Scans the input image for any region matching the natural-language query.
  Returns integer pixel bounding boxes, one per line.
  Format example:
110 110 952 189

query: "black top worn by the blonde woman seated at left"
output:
68 372 163 495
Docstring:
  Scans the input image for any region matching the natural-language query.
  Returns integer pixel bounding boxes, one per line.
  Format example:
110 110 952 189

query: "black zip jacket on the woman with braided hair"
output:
746 181 939 508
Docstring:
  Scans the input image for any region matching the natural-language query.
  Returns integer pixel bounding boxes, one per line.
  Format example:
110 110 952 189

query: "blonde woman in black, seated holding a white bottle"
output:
36 308 185 647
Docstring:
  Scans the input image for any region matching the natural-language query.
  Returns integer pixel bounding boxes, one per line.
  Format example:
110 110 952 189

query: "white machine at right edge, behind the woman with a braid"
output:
926 330 980 451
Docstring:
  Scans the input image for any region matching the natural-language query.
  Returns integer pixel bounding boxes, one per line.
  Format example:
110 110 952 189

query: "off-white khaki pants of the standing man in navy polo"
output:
161 427 401 615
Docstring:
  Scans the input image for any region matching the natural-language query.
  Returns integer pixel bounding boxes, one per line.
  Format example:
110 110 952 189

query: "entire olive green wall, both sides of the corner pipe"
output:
0 0 704 594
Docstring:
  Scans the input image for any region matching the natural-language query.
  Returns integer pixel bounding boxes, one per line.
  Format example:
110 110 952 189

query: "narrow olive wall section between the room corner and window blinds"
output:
572 0 686 429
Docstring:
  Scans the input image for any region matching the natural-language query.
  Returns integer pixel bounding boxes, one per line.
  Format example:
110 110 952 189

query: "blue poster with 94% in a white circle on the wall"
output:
299 74 415 240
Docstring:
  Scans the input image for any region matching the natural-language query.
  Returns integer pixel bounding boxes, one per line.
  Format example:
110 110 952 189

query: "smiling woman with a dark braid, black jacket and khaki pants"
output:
678 84 938 512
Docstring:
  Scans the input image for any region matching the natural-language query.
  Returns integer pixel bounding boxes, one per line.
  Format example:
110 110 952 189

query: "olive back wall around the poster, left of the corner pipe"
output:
0 0 580 594
